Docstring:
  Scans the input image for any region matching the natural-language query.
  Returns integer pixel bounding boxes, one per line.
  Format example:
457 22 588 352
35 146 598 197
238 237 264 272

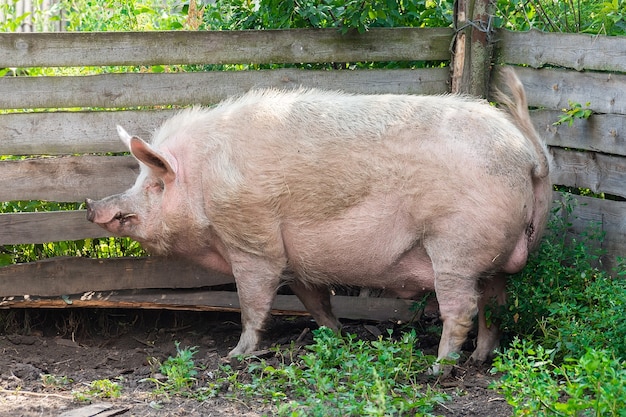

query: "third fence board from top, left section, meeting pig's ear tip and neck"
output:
0 110 177 155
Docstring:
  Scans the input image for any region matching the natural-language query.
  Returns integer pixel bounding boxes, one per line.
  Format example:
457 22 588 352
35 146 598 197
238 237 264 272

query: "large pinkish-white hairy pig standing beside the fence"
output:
87 70 551 368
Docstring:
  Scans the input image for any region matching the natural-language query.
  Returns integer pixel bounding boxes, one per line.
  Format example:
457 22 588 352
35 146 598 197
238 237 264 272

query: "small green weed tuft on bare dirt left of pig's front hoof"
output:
147 342 198 396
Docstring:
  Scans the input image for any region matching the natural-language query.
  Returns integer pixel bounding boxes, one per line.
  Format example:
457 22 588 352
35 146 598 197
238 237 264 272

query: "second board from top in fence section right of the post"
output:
492 67 626 114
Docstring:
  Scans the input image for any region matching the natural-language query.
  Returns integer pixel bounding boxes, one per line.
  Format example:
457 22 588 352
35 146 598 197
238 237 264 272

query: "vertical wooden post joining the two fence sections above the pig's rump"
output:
451 0 493 97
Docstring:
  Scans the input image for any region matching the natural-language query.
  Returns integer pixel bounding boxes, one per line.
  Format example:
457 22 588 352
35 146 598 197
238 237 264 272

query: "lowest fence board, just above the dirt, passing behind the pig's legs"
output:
0 290 416 322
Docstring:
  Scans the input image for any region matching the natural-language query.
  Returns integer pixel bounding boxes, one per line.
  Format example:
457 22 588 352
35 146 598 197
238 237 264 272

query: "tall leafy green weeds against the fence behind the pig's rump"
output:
503 197 626 359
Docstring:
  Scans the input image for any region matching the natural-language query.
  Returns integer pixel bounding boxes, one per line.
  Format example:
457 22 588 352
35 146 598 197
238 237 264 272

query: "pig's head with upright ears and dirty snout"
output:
86 126 185 254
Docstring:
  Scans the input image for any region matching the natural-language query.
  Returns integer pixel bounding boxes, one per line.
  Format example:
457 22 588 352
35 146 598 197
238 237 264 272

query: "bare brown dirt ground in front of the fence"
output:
0 309 512 417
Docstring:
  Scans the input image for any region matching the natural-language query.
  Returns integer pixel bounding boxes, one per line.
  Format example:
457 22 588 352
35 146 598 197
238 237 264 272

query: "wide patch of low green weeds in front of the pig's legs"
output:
209 328 449 417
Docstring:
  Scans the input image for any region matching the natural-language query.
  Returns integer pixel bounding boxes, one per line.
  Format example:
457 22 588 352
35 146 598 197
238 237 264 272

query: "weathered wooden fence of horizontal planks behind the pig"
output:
0 28 626 319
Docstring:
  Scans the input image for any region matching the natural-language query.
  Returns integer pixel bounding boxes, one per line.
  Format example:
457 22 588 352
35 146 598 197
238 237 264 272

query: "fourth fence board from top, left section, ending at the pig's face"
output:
0 155 139 202
